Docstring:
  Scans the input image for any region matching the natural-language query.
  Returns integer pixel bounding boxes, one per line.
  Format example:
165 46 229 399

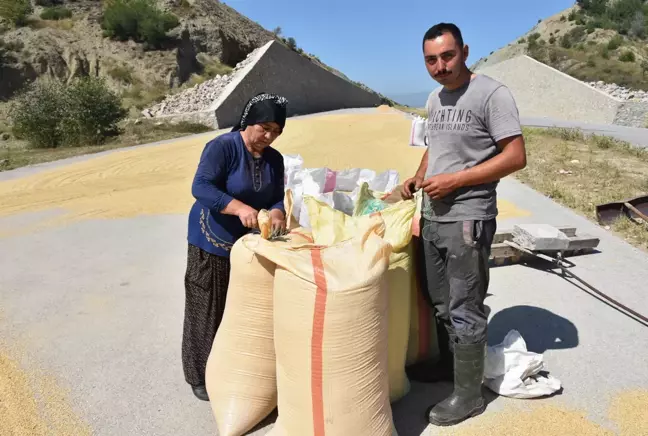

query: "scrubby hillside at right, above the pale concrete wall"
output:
472 0 648 93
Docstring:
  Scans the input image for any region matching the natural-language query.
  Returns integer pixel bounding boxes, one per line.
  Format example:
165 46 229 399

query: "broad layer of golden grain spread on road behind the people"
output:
0 111 527 237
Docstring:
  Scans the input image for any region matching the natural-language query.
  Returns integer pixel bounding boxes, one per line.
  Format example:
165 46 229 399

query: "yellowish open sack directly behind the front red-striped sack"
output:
304 197 416 402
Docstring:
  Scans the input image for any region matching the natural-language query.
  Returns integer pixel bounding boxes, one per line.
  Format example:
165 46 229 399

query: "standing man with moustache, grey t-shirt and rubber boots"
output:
403 23 526 425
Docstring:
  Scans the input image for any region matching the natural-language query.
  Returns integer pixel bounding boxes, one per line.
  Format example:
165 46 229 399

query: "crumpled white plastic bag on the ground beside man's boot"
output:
484 330 561 398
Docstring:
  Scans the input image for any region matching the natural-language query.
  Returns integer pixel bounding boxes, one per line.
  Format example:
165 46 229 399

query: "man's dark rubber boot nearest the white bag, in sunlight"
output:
427 342 486 426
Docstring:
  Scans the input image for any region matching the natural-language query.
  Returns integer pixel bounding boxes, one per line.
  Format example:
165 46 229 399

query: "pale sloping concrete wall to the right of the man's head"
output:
477 55 648 127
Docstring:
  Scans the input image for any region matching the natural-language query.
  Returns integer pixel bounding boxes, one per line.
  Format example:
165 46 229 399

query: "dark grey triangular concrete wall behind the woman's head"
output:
156 41 381 129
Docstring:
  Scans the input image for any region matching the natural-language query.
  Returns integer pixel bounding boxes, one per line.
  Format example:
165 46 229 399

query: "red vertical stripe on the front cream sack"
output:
311 250 326 436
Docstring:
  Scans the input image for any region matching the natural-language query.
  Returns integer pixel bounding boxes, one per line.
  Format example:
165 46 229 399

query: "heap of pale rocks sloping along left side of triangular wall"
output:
142 49 258 118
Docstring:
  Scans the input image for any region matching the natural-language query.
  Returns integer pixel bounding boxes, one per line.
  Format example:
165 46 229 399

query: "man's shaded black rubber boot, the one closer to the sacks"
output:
405 322 455 383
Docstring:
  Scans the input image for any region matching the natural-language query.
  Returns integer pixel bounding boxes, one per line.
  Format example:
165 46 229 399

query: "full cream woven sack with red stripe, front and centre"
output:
244 217 395 436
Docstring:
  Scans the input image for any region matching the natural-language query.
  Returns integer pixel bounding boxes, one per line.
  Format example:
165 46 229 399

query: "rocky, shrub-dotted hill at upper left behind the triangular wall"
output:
0 0 382 115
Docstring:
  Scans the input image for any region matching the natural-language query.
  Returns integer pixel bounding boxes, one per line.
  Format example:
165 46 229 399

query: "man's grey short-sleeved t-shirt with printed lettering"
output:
421 74 522 222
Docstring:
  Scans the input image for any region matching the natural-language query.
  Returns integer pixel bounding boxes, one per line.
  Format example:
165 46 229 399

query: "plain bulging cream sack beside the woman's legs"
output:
205 229 312 436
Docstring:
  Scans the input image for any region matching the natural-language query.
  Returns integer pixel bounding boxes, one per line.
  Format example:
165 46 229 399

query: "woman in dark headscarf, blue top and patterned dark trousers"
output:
182 93 287 401
